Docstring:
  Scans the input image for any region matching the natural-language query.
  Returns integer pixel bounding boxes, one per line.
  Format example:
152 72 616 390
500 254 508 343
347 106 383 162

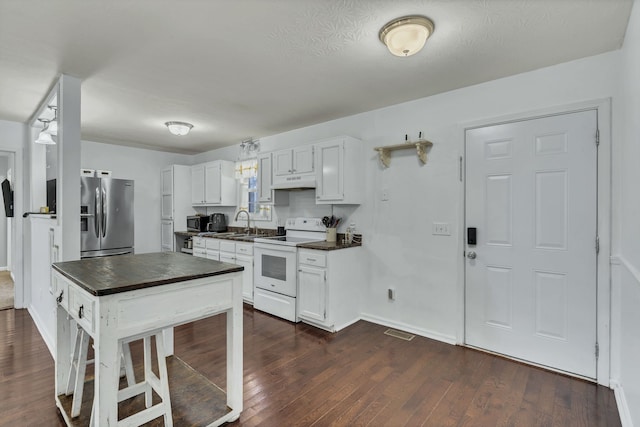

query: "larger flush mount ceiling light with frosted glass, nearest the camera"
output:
378 15 434 56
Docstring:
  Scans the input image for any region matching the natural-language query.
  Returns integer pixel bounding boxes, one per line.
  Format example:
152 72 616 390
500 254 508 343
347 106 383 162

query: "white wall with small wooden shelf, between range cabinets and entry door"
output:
196 52 620 342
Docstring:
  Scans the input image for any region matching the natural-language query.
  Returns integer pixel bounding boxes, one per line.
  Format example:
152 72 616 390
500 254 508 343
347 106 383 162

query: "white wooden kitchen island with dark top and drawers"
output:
52 252 243 426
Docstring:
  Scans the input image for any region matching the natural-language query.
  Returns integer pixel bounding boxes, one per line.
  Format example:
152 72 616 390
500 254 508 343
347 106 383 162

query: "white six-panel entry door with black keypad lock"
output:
465 110 597 378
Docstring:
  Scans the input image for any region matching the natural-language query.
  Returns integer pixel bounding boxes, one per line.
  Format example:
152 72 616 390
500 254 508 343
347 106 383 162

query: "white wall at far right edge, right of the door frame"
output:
612 3 640 425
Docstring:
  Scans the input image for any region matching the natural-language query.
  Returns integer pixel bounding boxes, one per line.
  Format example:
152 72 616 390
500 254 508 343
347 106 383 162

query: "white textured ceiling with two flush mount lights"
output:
0 0 632 153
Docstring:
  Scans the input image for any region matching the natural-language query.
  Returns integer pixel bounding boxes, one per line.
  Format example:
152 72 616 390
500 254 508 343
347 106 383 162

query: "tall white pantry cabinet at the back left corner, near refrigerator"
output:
160 165 193 252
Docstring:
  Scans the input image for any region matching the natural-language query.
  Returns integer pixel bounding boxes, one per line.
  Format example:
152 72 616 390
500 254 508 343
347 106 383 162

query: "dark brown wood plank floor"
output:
0 307 620 427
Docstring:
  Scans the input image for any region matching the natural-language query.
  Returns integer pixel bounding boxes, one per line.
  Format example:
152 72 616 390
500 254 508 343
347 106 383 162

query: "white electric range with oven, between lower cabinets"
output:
253 218 326 322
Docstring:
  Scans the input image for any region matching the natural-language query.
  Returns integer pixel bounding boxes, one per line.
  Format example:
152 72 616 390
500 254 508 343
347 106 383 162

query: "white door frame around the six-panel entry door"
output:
456 98 612 387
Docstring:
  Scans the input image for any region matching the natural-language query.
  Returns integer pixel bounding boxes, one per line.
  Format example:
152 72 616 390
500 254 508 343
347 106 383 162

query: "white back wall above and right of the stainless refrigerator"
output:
78 141 192 253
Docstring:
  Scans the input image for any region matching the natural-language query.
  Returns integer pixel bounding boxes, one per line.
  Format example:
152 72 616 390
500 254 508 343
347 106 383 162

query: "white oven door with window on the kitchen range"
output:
253 243 297 298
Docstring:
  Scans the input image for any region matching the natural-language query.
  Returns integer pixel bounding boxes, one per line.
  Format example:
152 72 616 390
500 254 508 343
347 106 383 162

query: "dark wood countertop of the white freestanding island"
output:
53 252 244 296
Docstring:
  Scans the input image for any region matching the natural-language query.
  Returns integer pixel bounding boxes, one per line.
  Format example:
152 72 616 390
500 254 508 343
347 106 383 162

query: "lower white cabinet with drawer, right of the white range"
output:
297 247 364 332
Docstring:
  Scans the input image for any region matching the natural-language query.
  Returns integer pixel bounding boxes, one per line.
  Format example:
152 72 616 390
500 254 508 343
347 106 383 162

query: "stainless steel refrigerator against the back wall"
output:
80 176 133 258
